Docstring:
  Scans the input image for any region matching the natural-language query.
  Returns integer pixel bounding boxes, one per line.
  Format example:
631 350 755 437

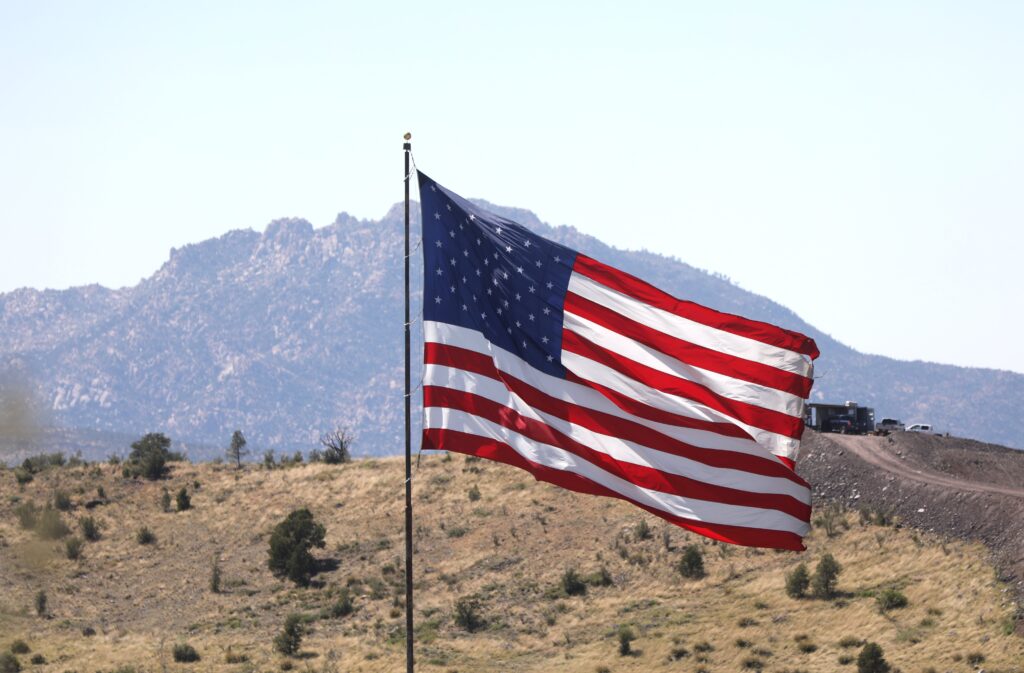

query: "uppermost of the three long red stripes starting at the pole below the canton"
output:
426 343 798 488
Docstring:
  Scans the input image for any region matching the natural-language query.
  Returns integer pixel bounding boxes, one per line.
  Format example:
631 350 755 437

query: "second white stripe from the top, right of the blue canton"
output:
564 310 804 418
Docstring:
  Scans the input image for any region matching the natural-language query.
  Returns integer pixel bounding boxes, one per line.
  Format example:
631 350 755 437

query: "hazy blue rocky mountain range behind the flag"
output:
0 202 1024 457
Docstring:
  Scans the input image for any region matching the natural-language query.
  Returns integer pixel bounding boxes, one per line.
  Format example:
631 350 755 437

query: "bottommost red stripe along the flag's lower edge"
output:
423 428 806 551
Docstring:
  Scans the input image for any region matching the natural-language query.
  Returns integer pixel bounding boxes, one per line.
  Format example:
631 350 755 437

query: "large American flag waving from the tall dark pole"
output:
419 173 818 550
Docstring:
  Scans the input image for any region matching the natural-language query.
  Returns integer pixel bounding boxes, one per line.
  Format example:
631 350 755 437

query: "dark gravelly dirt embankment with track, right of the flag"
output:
798 432 1024 618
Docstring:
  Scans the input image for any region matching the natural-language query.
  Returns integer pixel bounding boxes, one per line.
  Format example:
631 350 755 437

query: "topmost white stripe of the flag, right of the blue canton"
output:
569 271 813 377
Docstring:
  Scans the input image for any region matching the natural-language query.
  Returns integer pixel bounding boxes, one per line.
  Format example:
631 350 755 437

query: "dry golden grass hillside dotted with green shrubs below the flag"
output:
0 456 1024 673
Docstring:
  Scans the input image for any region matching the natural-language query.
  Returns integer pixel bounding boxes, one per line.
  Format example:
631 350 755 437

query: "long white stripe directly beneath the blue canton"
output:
423 321 771 458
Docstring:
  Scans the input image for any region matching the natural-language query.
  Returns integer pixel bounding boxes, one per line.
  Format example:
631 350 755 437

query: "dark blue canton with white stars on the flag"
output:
419 173 577 378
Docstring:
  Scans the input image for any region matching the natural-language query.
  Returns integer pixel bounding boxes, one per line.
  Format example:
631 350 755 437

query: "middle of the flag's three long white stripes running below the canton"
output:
425 365 810 504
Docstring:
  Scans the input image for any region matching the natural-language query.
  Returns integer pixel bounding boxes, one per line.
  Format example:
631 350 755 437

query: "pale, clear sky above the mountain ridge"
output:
0 0 1024 372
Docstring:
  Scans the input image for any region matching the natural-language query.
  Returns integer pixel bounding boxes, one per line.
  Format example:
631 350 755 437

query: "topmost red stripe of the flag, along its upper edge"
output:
572 255 819 359
